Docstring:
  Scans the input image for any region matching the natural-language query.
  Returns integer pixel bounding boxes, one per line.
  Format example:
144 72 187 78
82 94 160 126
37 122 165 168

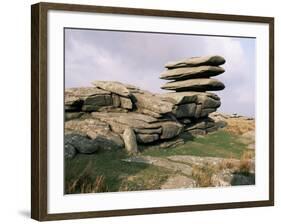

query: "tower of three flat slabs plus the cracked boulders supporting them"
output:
160 55 225 134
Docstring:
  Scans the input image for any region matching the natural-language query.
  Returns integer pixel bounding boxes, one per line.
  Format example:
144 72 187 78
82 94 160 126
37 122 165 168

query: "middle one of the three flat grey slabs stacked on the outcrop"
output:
160 65 224 80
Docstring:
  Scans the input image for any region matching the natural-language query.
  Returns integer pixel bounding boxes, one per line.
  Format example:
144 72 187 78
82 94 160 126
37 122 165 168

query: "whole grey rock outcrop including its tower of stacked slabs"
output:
65 56 225 157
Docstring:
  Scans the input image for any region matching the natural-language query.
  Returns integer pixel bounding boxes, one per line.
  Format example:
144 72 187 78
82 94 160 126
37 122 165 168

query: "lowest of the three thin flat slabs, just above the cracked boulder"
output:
161 78 225 92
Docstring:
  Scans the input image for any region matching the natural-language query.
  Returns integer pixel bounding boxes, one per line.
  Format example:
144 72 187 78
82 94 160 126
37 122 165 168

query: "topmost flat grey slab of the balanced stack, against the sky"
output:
165 55 225 69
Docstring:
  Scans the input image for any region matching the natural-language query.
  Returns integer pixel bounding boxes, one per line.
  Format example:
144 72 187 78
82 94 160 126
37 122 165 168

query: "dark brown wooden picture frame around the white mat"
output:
31 3 274 221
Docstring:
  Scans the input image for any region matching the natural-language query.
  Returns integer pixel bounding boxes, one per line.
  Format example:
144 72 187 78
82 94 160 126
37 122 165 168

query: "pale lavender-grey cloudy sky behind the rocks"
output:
65 29 256 117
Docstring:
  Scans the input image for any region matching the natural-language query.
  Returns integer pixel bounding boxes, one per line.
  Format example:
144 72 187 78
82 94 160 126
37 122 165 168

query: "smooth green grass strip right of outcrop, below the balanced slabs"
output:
142 130 246 158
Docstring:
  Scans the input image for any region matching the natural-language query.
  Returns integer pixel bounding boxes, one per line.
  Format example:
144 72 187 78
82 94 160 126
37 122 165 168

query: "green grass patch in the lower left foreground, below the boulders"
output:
65 151 169 193
